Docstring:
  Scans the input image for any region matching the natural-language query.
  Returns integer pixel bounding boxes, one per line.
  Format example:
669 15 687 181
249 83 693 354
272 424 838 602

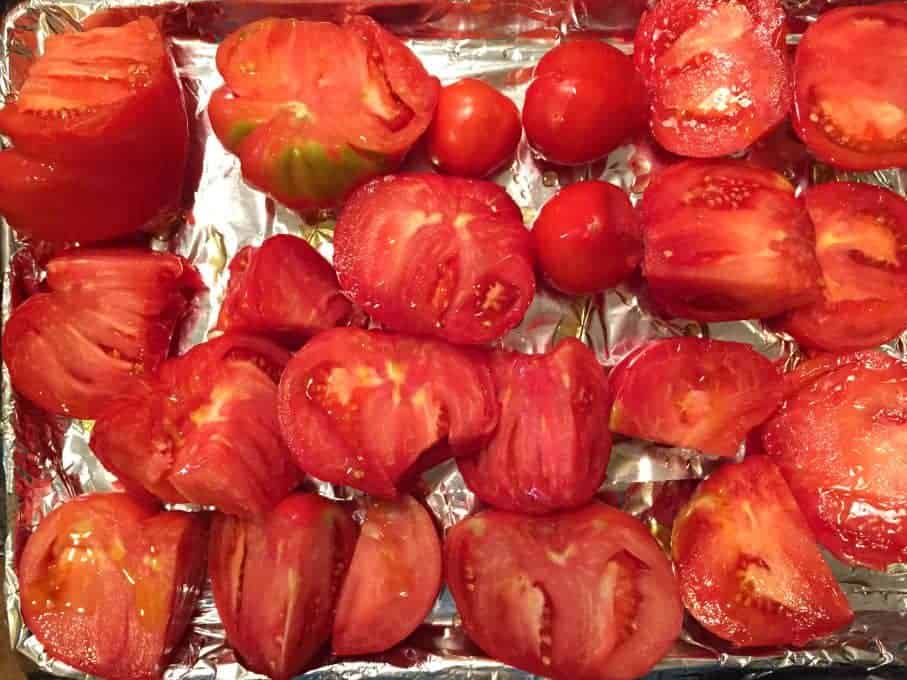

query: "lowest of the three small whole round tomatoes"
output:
532 180 642 295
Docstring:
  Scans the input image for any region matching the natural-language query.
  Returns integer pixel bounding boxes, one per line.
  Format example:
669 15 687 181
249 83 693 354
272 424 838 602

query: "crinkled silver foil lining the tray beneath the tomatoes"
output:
0 0 907 680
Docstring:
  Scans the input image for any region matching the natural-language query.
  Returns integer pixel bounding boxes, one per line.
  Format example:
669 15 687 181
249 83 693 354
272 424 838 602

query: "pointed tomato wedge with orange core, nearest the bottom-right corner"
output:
671 456 853 647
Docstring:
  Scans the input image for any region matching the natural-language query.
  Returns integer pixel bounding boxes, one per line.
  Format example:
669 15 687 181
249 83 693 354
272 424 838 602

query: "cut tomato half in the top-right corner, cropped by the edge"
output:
793 2 907 170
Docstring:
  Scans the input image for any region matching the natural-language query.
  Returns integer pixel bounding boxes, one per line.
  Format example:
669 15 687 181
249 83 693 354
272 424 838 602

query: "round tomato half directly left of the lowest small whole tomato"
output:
334 174 535 344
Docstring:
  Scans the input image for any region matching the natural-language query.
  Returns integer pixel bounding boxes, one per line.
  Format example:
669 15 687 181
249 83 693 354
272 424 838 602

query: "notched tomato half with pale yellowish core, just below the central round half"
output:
278 328 498 498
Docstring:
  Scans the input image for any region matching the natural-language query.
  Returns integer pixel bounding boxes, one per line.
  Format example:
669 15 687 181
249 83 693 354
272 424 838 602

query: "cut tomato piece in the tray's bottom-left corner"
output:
18 493 207 680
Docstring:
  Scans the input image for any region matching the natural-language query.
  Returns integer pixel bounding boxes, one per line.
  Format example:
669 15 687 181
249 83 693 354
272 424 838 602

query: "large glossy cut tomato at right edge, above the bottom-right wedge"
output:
763 352 907 570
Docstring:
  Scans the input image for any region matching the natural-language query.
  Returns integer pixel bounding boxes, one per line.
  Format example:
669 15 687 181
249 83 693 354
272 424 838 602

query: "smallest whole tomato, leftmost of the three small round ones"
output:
427 78 523 177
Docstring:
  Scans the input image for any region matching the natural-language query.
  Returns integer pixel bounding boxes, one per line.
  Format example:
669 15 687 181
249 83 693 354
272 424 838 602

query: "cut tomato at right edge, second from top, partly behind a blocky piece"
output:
777 182 907 352
